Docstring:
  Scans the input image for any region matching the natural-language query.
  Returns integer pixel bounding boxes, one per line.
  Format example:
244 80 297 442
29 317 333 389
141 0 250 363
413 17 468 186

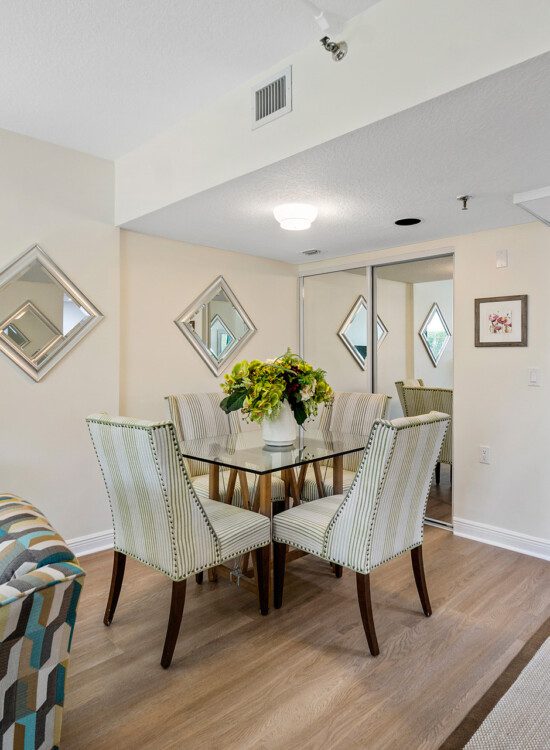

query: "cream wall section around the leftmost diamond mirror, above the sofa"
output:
0 131 119 538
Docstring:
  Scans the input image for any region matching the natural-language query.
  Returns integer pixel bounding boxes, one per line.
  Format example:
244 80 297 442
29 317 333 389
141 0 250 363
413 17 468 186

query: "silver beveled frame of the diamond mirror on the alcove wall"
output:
174 276 257 377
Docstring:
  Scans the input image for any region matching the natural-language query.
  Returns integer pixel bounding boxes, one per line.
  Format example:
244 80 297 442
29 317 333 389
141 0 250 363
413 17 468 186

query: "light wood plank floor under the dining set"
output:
62 527 550 750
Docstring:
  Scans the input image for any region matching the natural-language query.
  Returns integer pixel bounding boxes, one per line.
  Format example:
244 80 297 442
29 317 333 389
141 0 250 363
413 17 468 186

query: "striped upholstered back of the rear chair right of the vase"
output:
319 392 390 471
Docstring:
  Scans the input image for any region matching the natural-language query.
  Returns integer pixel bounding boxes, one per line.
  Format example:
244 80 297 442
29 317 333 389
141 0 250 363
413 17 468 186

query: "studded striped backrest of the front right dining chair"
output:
325 412 449 573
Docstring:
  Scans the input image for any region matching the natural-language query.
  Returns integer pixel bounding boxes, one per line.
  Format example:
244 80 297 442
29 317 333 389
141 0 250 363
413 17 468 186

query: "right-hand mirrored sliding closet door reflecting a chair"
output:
374 256 453 524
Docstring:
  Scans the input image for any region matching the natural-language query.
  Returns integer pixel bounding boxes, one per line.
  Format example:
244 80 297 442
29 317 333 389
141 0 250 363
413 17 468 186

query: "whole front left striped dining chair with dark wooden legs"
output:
86 414 271 669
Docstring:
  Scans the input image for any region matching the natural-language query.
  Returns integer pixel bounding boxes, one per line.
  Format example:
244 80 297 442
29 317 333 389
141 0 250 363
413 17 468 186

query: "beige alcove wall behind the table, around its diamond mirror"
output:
120 231 298 419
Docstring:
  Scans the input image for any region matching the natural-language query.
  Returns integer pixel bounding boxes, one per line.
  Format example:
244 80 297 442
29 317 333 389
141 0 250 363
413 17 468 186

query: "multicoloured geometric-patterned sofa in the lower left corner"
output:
0 494 84 750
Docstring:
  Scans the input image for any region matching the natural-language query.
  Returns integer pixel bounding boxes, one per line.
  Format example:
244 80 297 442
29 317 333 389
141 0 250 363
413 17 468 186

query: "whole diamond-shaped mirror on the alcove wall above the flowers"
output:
174 276 256 375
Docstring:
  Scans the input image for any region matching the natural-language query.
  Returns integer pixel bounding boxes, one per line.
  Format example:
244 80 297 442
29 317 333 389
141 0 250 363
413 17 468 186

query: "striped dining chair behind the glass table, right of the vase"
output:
301 392 390 502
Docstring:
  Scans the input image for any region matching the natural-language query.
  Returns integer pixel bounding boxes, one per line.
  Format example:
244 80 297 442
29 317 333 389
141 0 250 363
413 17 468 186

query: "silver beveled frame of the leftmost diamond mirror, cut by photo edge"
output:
0 245 103 382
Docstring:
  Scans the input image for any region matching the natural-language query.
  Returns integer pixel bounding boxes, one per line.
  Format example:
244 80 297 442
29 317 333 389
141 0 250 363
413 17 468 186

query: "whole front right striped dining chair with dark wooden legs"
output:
272 412 450 656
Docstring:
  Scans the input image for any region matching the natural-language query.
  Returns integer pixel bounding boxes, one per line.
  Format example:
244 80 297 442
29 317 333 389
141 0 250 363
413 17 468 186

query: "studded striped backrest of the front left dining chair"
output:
86 414 219 580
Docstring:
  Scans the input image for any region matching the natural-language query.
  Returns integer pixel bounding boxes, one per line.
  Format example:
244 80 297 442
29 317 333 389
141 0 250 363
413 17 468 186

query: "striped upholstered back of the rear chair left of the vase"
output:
166 393 241 477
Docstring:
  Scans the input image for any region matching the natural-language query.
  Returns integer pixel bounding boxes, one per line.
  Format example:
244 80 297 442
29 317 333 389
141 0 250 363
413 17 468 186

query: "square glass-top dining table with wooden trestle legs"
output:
180 428 368 517
